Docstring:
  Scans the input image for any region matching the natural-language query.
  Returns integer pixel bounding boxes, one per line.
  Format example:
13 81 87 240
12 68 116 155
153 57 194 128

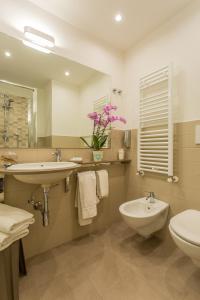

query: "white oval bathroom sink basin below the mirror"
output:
7 161 80 185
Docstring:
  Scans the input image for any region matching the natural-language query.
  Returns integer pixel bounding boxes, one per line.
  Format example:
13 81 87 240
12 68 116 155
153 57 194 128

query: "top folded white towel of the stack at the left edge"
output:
0 203 35 234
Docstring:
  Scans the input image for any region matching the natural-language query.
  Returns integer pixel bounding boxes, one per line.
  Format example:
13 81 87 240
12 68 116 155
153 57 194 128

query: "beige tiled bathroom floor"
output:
20 222 200 300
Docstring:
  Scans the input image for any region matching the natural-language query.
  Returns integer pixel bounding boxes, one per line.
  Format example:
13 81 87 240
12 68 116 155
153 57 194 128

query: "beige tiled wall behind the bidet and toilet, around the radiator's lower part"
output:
126 121 200 239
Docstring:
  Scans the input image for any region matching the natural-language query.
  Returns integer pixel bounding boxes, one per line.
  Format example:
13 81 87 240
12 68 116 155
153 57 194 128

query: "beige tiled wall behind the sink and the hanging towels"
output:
0 130 126 257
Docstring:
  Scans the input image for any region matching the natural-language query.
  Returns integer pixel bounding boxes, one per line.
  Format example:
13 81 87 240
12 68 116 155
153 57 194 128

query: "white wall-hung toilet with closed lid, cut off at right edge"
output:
169 209 200 267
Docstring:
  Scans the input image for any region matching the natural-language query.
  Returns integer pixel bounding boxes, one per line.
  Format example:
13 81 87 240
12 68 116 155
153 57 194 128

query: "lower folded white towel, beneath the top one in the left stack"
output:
0 228 29 251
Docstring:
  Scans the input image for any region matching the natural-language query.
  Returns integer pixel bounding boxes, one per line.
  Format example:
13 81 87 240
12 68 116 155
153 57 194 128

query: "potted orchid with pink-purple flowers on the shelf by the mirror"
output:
81 104 126 161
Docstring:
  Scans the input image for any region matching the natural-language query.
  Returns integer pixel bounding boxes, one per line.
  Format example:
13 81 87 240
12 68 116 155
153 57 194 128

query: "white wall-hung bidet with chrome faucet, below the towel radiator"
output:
119 198 169 238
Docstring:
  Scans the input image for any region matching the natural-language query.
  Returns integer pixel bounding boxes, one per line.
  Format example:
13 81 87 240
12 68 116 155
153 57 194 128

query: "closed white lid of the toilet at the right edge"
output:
170 209 200 246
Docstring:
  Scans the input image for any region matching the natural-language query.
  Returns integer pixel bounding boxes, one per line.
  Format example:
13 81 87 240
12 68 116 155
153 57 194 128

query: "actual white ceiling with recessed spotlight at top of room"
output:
30 0 191 50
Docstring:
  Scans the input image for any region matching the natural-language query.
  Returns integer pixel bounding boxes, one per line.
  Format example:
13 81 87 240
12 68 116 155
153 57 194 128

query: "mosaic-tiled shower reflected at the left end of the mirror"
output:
0 79 37 148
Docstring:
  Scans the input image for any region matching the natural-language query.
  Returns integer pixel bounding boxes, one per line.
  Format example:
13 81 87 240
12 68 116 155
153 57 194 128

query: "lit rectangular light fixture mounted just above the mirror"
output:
24 26 55 48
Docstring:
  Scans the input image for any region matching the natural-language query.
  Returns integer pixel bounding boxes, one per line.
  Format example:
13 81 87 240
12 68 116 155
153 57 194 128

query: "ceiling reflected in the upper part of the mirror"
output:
0 33 101 87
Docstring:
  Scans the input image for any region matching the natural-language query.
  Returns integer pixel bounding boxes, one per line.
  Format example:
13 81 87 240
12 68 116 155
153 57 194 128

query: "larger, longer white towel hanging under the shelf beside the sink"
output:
75 171 98 226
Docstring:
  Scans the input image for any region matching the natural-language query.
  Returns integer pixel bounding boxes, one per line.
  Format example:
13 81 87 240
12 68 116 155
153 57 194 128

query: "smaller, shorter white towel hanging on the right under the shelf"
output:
96 170 109 199
